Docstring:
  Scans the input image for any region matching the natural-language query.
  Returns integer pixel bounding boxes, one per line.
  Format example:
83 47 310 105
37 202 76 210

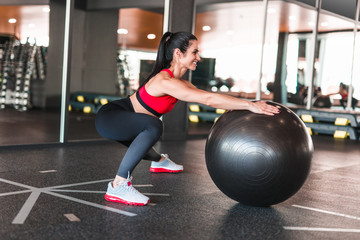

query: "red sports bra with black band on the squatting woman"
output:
136 69 178 117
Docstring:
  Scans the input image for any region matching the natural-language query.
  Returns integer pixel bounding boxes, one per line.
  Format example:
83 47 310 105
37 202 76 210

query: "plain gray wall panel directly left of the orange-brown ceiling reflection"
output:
83 9 119 94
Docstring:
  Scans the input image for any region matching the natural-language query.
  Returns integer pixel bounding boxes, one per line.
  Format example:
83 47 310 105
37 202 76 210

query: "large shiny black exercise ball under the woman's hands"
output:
205 102 314 207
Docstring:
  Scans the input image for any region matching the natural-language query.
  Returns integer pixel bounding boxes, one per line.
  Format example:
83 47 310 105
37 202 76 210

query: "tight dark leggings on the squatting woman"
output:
95 97 163 178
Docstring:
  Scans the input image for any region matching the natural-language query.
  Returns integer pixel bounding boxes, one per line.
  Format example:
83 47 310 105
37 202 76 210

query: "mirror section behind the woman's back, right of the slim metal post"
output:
69 8 164 140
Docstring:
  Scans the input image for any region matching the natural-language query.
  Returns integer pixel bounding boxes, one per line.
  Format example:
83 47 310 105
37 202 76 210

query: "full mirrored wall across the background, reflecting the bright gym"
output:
0 1 360 145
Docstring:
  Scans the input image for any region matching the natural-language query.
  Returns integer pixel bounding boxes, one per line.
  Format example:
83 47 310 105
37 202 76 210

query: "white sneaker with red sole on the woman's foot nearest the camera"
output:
105 174 150 206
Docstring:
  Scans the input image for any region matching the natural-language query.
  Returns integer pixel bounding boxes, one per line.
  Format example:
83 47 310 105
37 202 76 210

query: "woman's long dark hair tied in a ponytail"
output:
139 32 197 88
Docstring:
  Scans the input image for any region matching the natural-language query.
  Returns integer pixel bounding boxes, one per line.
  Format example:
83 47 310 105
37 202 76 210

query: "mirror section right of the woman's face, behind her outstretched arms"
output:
189 1 273 135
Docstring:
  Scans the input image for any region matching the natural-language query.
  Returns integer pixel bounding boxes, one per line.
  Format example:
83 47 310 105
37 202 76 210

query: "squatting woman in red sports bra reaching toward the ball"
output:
96 32 279 205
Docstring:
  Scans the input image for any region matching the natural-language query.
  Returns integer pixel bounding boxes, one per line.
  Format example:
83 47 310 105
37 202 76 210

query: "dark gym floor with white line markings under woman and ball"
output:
0 136 360 240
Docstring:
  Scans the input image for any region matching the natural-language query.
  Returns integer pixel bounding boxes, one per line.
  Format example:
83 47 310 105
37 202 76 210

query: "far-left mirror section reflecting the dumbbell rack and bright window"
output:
0 5 59 145
